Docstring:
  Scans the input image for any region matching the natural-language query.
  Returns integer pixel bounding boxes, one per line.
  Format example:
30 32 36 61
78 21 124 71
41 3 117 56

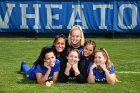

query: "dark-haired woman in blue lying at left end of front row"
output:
20 47 60 86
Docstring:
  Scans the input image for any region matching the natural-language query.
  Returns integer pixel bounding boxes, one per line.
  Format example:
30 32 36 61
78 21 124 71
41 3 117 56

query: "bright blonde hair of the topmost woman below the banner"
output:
68 25 85 46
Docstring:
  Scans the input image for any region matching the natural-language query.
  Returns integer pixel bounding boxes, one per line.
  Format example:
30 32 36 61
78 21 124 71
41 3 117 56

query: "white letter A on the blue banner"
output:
67 5 88 29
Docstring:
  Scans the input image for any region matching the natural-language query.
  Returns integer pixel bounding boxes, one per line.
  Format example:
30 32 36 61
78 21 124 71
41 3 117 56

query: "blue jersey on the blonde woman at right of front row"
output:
87 63 115 82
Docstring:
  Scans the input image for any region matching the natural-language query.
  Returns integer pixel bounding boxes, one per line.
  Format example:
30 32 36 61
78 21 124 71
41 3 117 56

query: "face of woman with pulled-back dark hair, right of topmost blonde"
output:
83 44 94 57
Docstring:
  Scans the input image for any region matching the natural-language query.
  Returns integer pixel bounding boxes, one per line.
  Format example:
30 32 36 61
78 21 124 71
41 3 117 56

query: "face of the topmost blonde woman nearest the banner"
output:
70 29 81 45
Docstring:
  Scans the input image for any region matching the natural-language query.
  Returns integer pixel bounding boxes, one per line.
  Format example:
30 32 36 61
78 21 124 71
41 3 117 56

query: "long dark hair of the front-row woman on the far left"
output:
34 47 55 68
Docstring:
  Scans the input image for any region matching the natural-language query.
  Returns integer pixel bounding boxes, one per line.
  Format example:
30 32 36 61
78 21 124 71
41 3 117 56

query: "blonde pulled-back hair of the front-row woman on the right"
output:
95 48 113 70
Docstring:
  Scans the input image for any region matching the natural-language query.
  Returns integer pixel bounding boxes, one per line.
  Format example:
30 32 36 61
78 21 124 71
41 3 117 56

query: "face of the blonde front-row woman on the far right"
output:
94 52 107 65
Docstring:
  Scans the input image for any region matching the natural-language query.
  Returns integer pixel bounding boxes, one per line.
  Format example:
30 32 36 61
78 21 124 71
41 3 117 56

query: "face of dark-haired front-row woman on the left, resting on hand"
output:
44 52 56 67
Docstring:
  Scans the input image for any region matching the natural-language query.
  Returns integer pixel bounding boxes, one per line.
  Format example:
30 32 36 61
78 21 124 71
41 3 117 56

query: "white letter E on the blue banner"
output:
45 4 62 29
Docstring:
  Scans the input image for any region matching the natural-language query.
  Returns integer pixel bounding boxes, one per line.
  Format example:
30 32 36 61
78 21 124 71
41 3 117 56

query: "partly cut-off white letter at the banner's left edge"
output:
0 3 15 29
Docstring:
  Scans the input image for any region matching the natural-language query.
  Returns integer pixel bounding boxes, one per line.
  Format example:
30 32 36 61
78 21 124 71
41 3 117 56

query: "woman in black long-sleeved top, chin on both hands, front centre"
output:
62 49 85 83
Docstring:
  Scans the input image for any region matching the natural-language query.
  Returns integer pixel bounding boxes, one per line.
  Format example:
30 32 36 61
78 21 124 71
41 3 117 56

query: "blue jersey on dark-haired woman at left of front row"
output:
27 59 60 80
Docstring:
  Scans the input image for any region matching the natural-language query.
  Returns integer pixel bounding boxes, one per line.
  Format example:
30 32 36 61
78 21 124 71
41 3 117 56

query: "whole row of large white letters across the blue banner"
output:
0 3 138 29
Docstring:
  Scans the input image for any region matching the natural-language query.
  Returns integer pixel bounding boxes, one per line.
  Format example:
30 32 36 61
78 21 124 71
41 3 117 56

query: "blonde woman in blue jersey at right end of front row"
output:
87 48 118 84
